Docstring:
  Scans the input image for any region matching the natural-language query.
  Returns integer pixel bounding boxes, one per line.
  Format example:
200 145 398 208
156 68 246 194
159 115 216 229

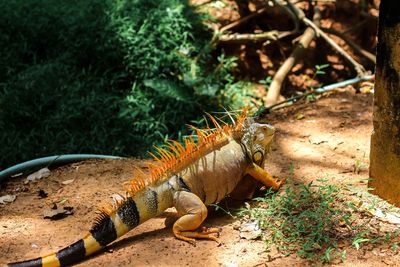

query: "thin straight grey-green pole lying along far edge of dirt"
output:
262 74 375 113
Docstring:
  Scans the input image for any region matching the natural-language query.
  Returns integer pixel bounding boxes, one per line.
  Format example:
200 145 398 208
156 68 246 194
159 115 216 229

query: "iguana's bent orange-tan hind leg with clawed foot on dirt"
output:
172 191 220 245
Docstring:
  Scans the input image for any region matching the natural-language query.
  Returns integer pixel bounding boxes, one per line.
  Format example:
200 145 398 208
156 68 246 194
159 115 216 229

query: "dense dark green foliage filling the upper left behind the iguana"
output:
0 0 244 168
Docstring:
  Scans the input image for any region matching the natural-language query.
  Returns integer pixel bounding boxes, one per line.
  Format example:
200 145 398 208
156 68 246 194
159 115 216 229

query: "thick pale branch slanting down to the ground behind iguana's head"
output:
265 7 321 106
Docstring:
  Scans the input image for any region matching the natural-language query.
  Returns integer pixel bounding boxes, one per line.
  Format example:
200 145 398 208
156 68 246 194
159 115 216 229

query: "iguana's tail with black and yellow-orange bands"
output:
8 189 164 267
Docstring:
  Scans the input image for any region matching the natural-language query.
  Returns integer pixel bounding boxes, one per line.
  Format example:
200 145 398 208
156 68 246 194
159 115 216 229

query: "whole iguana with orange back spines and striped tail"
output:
9 111 283 267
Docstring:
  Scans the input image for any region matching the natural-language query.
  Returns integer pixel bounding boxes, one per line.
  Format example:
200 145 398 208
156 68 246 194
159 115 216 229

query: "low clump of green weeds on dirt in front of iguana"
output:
239 179 348 258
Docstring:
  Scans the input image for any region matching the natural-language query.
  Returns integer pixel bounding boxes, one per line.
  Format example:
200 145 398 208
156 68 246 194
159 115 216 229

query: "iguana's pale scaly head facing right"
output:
241 118 275 166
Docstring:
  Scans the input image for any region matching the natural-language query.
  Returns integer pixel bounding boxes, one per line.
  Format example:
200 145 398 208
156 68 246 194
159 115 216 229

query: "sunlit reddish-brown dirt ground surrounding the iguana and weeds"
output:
0 92 400 266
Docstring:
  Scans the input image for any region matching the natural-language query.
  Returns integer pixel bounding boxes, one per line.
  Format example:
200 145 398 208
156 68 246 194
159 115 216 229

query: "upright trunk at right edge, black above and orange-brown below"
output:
369 0 400 206
